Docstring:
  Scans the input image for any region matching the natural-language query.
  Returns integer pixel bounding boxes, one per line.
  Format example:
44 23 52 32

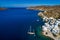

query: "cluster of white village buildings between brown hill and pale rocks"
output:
42 17 60 34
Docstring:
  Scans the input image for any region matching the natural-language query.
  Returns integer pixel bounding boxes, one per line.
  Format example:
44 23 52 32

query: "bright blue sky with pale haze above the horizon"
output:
0 0 60 7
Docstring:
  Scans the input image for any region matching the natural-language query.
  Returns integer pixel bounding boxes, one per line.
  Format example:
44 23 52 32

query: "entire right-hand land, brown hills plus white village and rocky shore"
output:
27 5 60 40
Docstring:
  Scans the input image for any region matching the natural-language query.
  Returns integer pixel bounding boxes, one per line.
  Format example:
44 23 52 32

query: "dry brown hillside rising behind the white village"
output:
28 5 60 19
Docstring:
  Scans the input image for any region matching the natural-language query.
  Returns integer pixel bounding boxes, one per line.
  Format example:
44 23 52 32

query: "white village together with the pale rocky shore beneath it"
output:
38 12 60 40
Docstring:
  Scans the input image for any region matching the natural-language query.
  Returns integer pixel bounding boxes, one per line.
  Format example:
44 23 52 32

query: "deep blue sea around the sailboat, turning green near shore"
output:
0 8 52 40
